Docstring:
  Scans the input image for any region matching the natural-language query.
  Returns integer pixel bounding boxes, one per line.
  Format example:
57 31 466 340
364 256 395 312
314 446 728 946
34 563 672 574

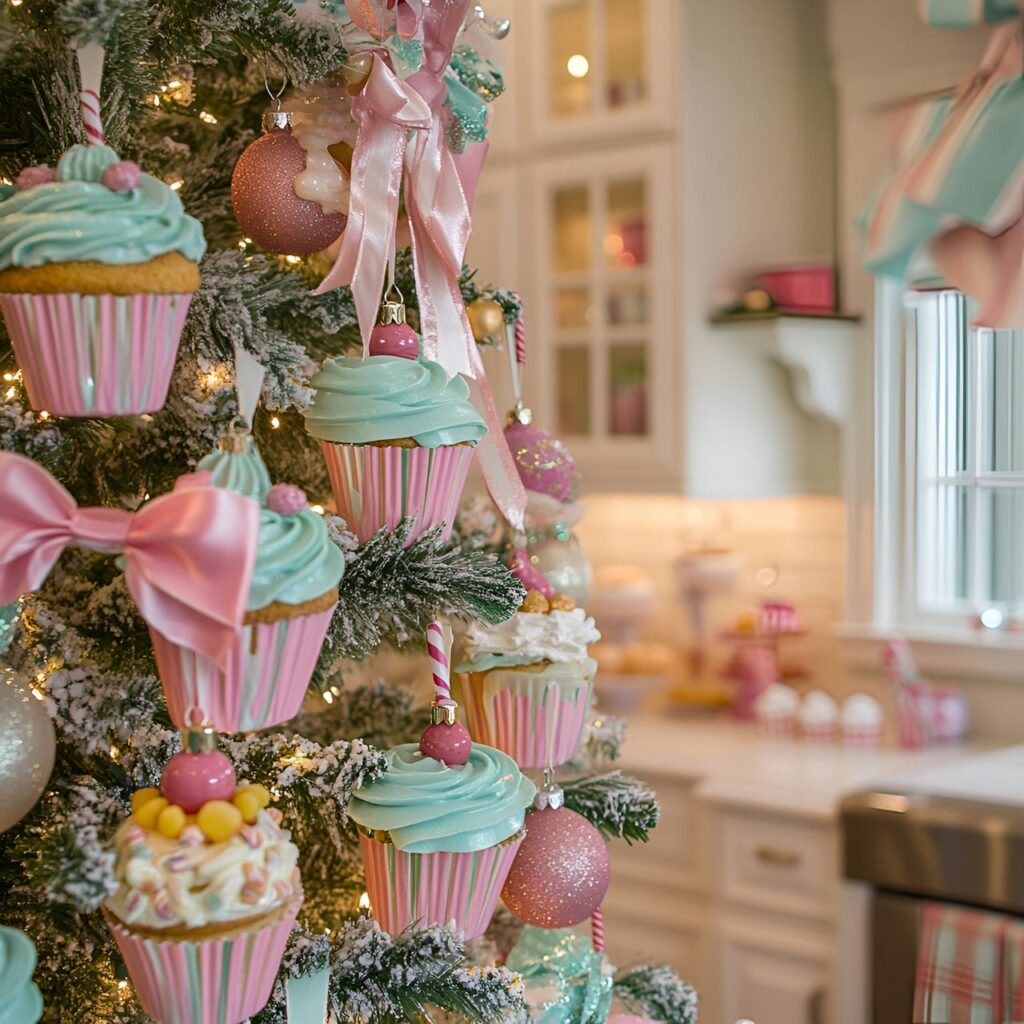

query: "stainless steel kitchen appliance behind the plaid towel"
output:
842 791 1024 1024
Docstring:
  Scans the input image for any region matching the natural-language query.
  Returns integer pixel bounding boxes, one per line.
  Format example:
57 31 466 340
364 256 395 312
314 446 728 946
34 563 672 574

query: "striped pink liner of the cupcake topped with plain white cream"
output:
461 665 594 769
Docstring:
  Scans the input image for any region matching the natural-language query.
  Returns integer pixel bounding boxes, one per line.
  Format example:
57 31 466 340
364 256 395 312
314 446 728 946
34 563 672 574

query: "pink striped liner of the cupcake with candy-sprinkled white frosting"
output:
104 899 302 1024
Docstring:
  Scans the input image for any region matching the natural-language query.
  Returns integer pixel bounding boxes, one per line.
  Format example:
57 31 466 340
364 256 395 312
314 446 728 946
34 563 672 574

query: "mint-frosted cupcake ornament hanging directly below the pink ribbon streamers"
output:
304 290 487 544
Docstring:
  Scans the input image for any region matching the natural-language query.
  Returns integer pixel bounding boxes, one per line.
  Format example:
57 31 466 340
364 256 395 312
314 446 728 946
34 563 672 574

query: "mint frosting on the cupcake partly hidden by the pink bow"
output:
196 437 345 611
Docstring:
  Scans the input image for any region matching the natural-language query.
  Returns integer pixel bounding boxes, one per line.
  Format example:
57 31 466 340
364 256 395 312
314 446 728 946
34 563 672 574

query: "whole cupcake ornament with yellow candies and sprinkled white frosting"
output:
103 727 302 1024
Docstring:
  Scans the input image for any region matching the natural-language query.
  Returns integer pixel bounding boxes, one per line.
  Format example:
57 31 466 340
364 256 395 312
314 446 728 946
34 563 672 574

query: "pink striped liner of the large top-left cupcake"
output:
0 292 191 416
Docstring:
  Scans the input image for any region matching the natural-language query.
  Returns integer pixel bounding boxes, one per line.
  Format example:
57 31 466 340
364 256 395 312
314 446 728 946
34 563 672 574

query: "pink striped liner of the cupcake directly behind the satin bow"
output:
150 605 337 732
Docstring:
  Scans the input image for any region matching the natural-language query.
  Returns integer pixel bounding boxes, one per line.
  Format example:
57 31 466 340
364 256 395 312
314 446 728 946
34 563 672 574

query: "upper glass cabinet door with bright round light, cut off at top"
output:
530 0 676 144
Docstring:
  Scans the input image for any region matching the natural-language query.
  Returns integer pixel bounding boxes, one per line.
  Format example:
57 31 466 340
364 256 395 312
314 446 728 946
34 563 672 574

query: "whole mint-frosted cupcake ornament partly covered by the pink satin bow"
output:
153 424 345 732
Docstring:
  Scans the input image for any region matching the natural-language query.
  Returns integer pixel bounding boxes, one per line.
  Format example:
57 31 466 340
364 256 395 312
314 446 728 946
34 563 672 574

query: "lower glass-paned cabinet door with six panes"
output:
535 144 675 487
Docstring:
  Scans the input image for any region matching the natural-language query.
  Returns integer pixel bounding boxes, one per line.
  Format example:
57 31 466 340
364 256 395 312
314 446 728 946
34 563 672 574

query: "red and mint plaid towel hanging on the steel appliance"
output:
913 903 1010 1024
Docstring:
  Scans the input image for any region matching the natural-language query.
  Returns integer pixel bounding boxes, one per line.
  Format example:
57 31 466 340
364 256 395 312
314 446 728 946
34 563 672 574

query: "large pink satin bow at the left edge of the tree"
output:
0 452 259 664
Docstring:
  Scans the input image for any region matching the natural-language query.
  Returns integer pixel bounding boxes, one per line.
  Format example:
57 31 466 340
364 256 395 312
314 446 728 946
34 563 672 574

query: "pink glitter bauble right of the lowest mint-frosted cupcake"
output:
502 807 609 928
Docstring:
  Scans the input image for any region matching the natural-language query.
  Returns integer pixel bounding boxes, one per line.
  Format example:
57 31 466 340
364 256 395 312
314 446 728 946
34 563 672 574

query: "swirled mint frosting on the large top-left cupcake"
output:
0 145 206 270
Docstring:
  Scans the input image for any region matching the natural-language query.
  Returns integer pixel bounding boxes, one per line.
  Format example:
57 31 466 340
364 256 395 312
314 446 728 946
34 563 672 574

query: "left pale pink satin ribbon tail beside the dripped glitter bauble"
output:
315 51 431 339
